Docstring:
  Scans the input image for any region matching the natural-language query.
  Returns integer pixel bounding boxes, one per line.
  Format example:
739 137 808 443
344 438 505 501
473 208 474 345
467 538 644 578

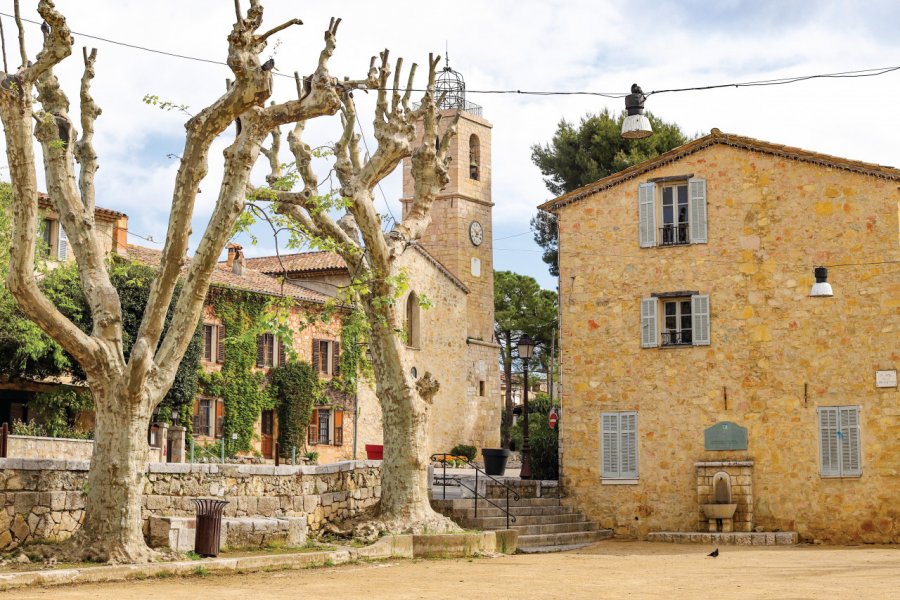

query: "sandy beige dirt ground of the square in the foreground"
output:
0 540 900 600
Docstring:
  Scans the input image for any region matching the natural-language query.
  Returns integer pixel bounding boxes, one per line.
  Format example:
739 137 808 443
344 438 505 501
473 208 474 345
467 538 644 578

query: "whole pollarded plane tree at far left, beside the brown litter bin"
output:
0 0 378 562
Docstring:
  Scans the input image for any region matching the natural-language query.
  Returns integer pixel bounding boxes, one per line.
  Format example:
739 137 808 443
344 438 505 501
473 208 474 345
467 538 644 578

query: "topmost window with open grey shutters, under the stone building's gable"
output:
638 177 707 248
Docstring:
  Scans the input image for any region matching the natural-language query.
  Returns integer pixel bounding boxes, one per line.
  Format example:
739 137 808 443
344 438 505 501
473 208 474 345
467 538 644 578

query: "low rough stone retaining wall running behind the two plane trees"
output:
0 458 381 550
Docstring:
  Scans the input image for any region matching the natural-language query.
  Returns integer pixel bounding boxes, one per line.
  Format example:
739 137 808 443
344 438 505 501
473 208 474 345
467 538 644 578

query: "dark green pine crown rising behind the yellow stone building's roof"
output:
531 109 691 275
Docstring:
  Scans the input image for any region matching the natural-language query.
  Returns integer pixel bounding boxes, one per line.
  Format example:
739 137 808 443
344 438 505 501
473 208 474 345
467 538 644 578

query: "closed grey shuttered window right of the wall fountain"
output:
819 406 862 477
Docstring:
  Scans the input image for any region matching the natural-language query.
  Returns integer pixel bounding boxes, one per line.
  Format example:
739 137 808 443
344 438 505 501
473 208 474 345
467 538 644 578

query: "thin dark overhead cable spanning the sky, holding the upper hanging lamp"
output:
0 12 900 99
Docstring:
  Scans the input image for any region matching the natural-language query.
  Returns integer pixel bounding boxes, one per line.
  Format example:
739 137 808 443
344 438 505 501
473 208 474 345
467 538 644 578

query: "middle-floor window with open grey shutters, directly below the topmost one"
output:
641 294 709 348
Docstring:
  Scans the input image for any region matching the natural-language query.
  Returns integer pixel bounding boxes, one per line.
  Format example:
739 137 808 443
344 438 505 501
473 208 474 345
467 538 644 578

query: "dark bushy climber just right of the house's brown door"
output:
270 362 323 456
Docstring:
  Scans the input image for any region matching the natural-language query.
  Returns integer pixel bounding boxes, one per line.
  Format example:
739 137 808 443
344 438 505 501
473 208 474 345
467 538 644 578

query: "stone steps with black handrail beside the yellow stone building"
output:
431 479 612 552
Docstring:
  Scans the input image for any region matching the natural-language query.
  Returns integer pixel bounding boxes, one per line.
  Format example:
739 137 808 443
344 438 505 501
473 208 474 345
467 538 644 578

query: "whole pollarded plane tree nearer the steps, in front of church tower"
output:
249 50 459 537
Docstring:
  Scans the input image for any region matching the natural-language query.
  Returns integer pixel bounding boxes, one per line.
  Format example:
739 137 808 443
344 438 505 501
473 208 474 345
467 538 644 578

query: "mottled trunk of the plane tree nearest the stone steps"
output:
365 303 459 533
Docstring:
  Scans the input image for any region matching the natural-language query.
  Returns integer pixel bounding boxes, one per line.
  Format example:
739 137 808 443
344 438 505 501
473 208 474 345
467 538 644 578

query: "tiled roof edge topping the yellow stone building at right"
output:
538 128 900 212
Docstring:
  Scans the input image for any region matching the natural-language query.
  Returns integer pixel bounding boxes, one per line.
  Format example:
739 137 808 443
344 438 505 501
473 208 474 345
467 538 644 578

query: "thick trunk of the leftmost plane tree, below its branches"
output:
72 385 152 563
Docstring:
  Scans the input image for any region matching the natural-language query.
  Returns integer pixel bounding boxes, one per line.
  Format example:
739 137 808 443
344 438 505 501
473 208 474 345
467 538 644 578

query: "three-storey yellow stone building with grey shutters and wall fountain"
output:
541 129 900 543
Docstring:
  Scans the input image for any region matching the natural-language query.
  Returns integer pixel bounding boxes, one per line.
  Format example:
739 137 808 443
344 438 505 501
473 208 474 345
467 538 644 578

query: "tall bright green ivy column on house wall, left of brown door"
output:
199 290 274 452
